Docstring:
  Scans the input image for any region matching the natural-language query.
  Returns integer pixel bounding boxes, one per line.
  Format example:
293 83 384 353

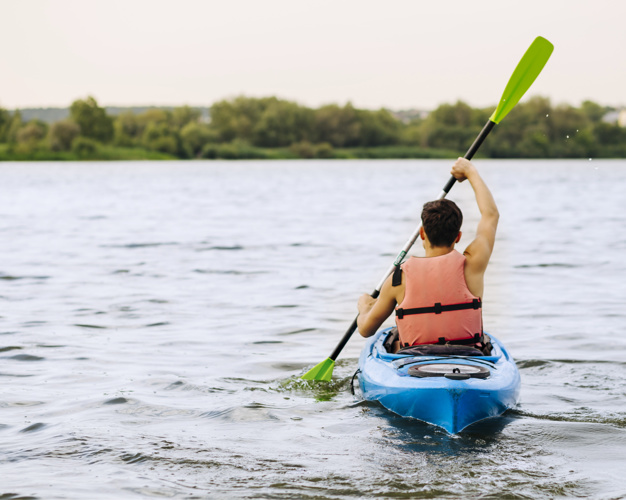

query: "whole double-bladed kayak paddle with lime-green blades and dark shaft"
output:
302 36 554 381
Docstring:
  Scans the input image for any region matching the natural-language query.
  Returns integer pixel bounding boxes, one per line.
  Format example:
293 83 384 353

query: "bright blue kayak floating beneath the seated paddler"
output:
358 328 521 434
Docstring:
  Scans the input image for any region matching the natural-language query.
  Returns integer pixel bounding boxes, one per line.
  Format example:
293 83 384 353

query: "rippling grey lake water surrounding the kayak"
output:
0 160 626 500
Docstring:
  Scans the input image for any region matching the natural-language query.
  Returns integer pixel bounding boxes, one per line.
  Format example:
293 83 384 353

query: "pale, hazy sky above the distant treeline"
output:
0 0 626 110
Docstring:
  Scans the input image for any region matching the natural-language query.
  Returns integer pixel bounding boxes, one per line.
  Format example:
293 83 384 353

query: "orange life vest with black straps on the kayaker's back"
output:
396 250 483 346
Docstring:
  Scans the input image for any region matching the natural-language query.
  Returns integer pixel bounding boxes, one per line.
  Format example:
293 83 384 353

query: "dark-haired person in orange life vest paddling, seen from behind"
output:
357 158 499 352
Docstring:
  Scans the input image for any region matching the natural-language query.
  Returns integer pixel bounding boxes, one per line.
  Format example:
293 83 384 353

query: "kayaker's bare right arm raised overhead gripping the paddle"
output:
451 158 500 297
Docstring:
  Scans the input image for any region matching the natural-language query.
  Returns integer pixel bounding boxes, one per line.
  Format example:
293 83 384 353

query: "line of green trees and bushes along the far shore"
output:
0 97 626 159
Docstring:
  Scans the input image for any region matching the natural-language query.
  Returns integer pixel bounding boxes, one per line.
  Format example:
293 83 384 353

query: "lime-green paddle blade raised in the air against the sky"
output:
489 36 554 123
